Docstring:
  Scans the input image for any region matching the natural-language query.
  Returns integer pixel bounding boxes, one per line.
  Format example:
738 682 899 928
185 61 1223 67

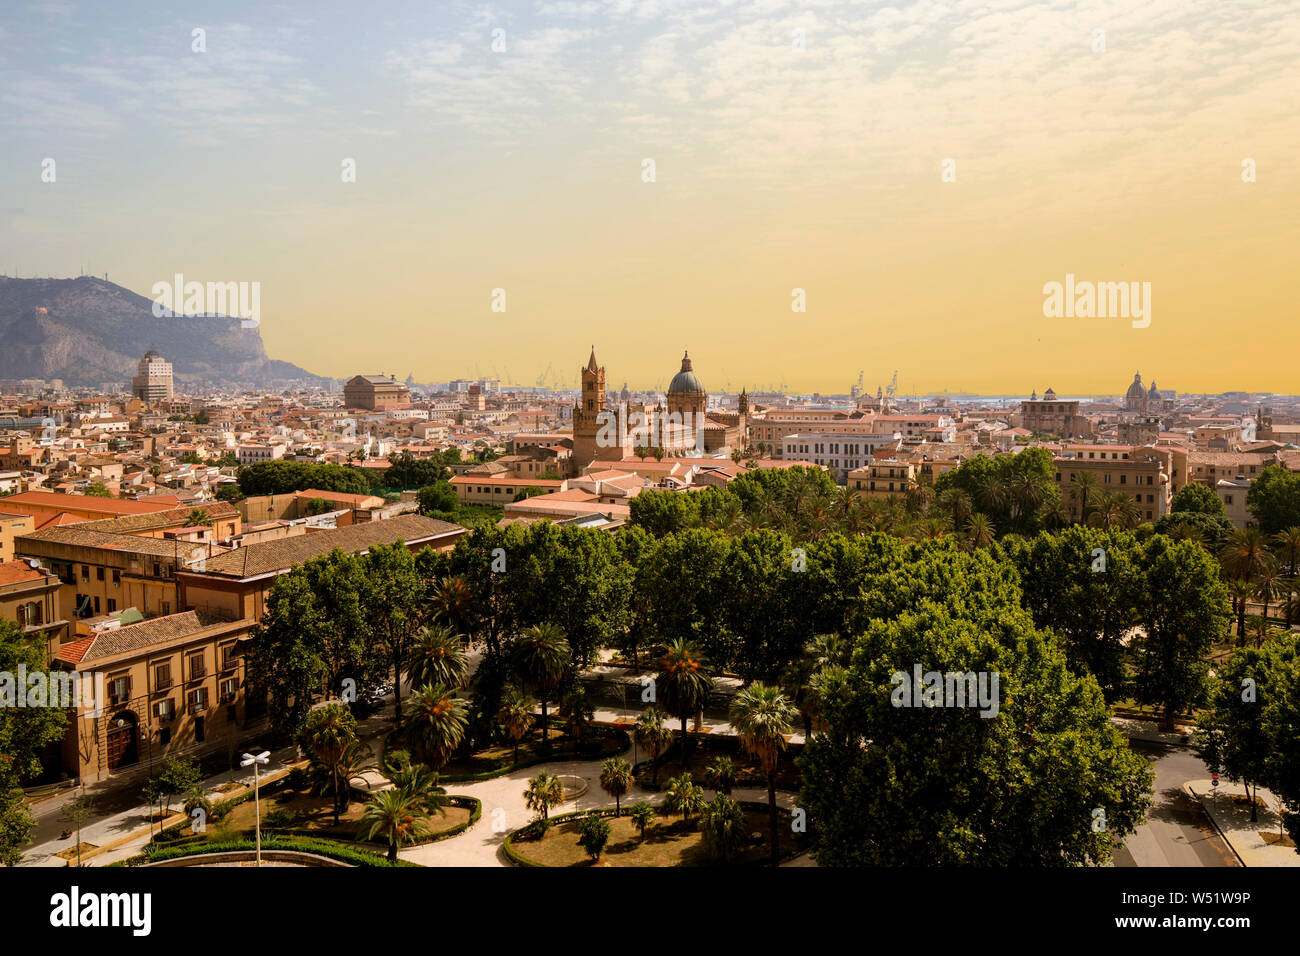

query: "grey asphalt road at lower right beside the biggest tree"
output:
1115 740 1242 866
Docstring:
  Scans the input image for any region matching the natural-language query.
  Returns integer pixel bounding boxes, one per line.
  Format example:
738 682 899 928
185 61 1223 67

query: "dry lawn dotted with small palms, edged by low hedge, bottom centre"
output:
512 809 796 866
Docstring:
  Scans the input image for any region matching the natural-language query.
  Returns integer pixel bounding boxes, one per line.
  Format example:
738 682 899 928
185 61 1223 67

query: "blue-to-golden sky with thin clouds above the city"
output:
0 0 1300 395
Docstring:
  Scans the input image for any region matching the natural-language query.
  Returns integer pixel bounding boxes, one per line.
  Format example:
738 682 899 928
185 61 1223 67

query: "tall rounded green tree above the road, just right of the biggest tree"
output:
1134 535 1229 731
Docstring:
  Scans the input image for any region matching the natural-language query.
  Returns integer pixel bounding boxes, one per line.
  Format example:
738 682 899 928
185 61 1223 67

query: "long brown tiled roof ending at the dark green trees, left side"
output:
189 515 464 578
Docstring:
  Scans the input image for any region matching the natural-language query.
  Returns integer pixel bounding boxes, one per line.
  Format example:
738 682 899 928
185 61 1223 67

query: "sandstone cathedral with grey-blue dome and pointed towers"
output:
572 346 749 473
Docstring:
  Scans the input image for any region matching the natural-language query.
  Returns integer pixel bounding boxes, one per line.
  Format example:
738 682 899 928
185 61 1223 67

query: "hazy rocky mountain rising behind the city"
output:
0 276 329 385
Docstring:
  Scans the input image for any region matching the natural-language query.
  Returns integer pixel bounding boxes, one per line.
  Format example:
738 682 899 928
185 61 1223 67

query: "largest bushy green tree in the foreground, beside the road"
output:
796 542 1152 866
